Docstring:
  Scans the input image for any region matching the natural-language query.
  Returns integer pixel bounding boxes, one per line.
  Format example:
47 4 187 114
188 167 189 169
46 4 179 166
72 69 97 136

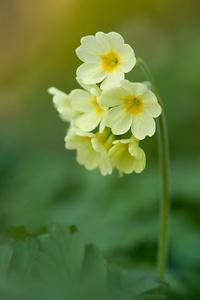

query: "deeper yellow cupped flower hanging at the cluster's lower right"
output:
108 136 146 174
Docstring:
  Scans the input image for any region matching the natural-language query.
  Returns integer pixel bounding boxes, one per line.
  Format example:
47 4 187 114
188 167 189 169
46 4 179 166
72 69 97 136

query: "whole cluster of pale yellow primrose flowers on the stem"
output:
49 32 161 175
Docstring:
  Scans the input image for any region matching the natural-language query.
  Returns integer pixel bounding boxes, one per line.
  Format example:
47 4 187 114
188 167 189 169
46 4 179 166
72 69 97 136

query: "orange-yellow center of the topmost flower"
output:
101 51 120 72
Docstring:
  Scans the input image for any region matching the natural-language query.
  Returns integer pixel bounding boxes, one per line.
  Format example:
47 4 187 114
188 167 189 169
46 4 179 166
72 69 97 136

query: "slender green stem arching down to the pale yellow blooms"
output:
137 58 170 279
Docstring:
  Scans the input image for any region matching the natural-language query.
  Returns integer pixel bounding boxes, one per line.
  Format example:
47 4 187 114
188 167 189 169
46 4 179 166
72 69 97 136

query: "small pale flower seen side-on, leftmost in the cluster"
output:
48 87 75 122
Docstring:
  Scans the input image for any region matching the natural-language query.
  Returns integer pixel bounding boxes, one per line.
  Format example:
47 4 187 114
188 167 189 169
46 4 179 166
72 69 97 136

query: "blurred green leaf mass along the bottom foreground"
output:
0 224 164 300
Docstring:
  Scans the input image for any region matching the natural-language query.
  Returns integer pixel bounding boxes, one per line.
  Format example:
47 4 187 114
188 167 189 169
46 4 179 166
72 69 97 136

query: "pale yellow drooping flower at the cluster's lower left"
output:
65 128 112 175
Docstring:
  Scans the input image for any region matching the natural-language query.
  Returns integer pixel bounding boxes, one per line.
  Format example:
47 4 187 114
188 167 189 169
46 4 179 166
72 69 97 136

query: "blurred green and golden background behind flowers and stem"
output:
0 0 200 299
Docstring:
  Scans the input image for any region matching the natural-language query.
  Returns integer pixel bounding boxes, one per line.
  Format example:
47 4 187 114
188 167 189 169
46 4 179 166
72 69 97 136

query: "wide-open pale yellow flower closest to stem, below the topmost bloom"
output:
99 80 161 140
